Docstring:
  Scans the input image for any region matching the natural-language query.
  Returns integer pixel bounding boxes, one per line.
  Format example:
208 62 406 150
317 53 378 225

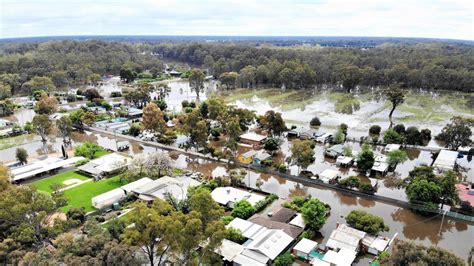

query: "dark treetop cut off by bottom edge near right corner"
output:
381 240 466 266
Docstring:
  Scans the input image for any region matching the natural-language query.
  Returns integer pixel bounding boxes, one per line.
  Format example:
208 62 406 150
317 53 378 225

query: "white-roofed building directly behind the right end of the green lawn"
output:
78 153 131 178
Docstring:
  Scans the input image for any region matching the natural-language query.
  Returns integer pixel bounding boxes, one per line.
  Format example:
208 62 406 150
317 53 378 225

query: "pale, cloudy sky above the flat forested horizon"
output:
0 0 474 40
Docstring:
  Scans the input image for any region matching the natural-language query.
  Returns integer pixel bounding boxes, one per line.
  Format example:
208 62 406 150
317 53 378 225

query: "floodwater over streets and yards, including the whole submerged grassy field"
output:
0 79 474 258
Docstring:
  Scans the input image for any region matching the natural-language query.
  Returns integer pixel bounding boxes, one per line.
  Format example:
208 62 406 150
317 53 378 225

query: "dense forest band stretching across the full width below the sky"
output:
0 40 474 92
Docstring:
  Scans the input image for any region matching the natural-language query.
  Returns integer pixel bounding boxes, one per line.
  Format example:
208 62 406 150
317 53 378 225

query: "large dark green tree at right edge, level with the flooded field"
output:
436 116 474 150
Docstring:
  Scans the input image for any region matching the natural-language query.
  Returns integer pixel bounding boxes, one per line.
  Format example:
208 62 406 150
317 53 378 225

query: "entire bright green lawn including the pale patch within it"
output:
31 171 124 212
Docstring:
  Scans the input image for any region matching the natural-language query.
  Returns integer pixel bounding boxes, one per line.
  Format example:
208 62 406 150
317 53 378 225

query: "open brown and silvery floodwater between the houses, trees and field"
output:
0 82 474 264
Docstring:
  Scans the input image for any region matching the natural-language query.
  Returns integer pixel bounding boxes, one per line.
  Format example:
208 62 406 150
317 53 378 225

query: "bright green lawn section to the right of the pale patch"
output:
60 176 124 212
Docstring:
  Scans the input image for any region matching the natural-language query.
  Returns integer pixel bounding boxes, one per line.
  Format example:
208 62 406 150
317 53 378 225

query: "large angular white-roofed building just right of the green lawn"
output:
132 176 201 201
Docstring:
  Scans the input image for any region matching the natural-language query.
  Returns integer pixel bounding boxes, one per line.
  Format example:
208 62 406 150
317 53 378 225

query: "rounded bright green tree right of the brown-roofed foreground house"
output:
301 199 327 232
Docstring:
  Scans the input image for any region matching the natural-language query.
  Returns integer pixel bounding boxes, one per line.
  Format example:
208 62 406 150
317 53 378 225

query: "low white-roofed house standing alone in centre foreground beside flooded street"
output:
211 187 265 209
